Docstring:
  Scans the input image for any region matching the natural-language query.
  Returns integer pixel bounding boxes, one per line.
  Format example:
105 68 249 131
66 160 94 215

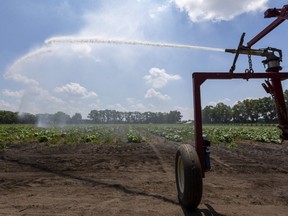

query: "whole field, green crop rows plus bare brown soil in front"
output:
0 124 288 216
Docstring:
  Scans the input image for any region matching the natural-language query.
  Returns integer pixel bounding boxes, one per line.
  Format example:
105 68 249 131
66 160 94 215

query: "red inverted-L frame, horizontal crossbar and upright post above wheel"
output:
192 72 288 178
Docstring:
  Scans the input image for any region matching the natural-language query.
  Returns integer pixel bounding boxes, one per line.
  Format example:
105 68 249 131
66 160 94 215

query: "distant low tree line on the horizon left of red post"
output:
0 109 182 125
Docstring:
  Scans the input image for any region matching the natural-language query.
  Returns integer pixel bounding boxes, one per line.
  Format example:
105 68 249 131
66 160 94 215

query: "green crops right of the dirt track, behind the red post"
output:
142 125 282 144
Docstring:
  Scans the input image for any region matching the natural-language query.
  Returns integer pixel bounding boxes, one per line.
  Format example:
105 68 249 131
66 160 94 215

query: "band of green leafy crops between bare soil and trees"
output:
0 124 281 149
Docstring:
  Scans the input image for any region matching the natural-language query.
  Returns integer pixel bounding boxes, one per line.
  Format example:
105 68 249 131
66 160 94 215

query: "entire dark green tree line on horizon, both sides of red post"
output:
0 90 288 125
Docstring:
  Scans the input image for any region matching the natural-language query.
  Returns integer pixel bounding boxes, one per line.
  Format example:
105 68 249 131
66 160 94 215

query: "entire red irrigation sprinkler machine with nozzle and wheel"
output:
175 5 288 209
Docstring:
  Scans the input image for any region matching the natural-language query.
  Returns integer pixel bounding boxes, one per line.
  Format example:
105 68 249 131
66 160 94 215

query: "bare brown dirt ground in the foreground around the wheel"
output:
0 129 288 216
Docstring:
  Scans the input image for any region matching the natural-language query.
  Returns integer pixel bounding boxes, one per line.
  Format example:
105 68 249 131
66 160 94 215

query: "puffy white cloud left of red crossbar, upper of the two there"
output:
144 68 181 88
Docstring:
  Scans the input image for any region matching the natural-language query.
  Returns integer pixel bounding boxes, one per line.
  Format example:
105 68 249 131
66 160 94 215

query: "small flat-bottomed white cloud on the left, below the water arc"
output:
54 82 97 98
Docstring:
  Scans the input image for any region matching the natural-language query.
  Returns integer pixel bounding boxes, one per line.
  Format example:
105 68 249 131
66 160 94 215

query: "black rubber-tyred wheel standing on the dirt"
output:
175 144 203 209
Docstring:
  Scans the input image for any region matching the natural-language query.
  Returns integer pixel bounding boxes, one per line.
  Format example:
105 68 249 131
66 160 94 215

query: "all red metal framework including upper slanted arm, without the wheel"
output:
192 5 288 178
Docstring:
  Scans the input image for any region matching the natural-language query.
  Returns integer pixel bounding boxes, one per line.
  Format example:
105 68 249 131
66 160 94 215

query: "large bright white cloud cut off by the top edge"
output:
172 0 268 22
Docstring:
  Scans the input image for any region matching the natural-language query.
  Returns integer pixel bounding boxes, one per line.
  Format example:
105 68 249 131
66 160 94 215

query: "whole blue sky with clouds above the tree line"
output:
0 0 288 119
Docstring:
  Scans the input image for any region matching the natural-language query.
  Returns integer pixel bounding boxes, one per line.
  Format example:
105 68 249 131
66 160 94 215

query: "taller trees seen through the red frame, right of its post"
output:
202 90 288 123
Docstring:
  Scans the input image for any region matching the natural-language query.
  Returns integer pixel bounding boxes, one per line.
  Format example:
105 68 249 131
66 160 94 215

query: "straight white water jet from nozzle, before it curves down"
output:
45 37 225 52
